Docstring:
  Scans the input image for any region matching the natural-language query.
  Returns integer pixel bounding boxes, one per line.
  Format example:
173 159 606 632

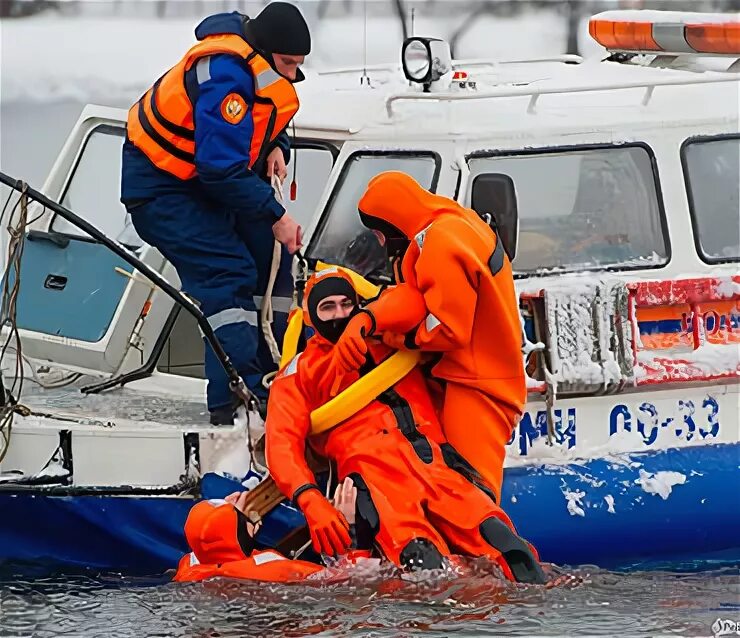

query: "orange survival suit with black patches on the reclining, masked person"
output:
265 269 544 582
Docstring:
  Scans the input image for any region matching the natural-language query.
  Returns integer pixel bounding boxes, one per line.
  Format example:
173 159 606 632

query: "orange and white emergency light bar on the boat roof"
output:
588 11 740 56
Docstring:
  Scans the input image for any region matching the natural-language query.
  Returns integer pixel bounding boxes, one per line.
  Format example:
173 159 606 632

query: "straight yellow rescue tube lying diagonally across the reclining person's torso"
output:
311 350 421 434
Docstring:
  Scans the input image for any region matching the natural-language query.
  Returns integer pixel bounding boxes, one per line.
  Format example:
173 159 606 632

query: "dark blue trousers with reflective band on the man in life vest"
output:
129 194 293 410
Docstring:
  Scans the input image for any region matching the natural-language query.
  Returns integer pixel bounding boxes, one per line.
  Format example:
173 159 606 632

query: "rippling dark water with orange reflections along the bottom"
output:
0 562 740 638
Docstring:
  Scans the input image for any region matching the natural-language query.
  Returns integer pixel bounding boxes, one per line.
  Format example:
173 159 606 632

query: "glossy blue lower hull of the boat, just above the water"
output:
0 443 740 574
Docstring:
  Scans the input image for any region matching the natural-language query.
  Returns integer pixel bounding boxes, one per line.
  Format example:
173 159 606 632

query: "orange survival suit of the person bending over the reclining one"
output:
338 171 527 499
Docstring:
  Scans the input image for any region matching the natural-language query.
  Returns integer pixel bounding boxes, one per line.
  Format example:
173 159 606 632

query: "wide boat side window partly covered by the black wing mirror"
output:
466 145 669 274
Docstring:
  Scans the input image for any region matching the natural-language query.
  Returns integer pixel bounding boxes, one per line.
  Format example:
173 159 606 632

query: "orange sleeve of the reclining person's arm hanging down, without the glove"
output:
265 355 316 499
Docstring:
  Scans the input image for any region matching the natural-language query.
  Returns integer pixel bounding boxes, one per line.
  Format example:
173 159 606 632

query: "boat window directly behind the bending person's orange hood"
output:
308 151 440 275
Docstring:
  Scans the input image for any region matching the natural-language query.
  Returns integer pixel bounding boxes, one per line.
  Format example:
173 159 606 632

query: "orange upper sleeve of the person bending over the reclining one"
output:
415 226 478 352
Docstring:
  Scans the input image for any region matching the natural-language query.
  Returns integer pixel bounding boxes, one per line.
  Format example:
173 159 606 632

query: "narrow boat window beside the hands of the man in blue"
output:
284 140 338 228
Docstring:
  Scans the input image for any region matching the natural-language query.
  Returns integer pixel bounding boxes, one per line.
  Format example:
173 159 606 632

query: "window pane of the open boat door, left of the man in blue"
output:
51 125 142 248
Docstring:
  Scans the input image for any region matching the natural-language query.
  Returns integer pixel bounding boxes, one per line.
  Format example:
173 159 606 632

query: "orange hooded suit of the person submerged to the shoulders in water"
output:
174 500 323 583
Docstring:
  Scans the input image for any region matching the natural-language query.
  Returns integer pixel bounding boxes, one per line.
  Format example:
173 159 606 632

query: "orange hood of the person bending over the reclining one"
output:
357 171 464 239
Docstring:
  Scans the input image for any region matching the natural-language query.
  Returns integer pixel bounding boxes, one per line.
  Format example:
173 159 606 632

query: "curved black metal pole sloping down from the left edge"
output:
0 172 250 403
